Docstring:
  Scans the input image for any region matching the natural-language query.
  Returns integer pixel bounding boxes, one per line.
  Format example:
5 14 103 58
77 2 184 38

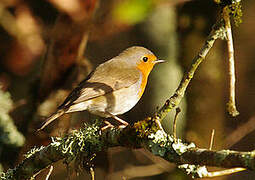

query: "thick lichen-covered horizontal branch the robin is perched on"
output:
1 120 255 180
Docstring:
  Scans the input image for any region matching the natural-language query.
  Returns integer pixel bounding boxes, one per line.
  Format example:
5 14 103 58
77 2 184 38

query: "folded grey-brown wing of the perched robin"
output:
59 59 140 109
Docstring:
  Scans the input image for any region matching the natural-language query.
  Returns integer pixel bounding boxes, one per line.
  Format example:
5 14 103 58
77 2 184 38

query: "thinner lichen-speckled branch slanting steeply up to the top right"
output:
154 0 242 121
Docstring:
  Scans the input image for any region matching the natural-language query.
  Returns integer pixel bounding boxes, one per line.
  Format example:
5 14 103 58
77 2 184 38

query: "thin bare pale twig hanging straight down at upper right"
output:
223 6 239 117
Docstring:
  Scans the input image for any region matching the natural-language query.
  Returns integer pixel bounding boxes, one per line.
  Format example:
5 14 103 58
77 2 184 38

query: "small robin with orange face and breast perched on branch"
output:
38 46 165 130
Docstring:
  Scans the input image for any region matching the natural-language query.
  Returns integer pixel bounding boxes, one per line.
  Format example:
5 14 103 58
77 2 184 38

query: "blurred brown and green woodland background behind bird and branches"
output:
0 0 255 180
